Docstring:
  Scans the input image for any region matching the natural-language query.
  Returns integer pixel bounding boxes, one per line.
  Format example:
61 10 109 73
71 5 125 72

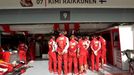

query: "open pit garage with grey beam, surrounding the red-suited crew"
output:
0 0 134 75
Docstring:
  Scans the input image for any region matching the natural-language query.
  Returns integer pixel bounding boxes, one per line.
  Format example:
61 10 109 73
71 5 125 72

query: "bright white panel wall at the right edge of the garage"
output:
119 26 134 70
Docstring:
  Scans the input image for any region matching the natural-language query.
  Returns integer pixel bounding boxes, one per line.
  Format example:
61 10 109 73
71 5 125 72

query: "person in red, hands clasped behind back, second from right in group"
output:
90 37 101 71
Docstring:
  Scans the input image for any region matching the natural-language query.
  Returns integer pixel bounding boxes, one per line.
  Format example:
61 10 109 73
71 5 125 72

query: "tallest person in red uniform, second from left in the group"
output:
56 32 69 75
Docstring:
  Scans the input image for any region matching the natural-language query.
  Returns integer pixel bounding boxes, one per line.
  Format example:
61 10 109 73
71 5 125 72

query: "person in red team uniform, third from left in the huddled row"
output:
68 35 78 75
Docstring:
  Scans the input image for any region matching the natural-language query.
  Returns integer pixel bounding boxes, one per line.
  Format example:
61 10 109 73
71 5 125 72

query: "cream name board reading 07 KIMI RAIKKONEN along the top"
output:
0 0 134 9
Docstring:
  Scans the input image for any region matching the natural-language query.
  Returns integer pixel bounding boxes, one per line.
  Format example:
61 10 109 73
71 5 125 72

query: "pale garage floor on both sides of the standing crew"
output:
23 60 129 75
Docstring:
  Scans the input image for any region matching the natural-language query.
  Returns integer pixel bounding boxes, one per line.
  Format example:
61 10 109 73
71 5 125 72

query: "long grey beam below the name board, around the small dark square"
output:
0 8 134 24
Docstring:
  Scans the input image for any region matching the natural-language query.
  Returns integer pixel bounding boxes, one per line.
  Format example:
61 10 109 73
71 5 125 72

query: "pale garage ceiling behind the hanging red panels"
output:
7 23 112 34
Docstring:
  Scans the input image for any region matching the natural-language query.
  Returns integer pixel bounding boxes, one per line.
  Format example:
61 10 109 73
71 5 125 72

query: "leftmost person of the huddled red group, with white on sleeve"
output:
48 36 57 73
